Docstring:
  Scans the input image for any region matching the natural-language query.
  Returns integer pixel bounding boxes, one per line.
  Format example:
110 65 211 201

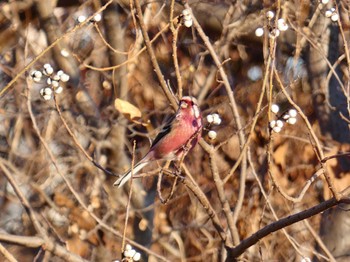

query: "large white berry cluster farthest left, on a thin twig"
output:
30 64 69 100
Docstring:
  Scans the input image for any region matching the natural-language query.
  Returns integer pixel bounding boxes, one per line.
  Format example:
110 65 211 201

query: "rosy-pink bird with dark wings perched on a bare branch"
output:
113 96 202 188
